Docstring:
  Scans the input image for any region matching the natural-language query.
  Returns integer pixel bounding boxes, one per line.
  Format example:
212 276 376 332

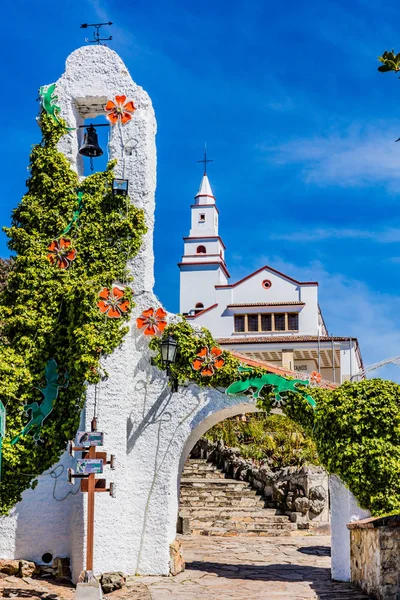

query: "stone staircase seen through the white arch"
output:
178 458 297 537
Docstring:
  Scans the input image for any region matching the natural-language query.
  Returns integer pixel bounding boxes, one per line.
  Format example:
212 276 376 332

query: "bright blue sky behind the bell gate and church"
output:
0 0 400 380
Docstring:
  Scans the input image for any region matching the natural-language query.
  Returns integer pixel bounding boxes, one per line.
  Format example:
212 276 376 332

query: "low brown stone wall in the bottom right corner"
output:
347 515 400 600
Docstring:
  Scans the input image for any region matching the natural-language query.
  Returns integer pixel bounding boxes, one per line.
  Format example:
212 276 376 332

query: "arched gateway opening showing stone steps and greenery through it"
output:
178 407 329 537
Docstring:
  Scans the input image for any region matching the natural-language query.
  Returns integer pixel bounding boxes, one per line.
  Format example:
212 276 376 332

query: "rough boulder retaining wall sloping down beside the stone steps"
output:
191 438 329 529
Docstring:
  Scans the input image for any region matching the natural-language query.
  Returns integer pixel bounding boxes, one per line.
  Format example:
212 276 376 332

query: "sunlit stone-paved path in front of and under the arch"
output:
136 536 368 600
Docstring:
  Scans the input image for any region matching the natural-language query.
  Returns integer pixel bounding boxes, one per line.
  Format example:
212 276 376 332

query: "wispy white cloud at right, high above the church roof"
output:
261 121 400 192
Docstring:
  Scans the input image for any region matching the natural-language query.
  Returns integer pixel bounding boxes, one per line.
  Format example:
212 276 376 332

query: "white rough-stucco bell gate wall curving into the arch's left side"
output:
0 46 368 581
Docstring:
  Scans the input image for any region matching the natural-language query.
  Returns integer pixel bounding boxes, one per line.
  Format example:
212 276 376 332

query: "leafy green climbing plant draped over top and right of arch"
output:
150 320 400 515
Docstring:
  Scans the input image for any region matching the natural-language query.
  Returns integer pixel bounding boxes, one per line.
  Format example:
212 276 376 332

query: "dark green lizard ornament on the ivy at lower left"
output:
11 358 68 446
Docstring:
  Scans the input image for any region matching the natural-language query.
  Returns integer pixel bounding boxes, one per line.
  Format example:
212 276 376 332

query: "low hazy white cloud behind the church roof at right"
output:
232 256 400 383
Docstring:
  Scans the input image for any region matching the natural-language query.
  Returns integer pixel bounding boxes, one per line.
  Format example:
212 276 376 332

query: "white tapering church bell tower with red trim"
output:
178 169 229 314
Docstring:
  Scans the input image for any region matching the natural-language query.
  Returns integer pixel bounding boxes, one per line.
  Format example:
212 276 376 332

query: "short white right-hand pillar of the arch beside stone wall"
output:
329 475 370 581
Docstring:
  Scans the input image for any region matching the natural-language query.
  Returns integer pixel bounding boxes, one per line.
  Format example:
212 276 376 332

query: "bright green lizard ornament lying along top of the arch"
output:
225 367 317 408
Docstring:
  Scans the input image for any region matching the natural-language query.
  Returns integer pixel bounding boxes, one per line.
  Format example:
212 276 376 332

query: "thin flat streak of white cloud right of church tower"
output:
270 227 400 244
